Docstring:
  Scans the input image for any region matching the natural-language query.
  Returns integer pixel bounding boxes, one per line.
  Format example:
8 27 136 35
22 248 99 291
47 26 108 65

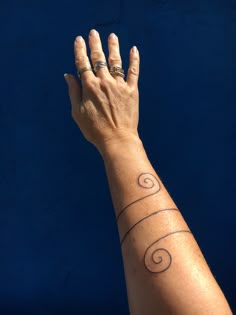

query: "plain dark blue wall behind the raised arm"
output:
0 0 236 315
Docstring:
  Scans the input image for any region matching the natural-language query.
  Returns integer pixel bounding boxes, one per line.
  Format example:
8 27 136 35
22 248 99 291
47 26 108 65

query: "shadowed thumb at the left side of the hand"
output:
64 73 82 108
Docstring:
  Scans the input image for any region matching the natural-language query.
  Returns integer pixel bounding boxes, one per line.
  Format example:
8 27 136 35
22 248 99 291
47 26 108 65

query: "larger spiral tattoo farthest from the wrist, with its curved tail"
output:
144 230 192 273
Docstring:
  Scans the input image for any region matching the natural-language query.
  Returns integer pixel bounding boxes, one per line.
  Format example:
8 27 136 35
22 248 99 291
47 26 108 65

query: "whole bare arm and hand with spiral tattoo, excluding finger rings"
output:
66 32 232 315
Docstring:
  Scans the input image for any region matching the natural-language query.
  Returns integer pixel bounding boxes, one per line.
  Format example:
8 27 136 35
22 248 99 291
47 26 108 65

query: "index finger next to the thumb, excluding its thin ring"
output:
74 36 95 81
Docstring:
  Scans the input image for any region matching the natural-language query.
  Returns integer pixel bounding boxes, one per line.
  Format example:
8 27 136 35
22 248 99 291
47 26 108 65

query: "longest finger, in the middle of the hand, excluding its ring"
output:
89 29 110 78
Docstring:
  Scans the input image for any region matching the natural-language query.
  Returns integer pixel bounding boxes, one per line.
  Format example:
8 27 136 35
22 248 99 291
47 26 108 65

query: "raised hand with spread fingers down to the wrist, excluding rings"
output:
65 31 140 155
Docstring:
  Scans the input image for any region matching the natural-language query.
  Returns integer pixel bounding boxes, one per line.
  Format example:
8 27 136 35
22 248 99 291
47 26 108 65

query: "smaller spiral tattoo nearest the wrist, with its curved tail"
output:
116 173 161 221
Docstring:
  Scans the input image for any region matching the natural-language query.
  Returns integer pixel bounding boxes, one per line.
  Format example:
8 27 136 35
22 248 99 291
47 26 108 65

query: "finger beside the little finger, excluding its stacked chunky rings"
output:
108 33 124 81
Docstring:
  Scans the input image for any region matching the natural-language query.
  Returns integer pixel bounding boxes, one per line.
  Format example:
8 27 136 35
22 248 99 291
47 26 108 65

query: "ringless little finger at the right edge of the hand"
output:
126 46 140 87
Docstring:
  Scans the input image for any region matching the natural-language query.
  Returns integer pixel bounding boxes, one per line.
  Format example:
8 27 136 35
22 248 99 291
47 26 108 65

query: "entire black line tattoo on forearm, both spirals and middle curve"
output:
117 173 191 273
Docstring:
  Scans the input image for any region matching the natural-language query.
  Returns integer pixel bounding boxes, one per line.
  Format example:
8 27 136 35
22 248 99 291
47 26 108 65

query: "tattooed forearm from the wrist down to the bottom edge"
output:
102 138 232 315
